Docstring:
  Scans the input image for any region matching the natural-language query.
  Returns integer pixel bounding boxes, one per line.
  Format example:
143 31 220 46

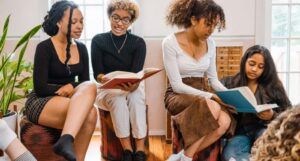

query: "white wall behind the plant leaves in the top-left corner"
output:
0 0 48 61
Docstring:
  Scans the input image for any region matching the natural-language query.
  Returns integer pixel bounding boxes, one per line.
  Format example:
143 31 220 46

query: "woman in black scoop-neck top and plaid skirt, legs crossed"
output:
25 0 97 161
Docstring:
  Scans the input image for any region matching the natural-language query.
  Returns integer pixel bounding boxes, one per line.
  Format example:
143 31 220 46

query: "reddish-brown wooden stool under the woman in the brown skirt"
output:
172 117 221 161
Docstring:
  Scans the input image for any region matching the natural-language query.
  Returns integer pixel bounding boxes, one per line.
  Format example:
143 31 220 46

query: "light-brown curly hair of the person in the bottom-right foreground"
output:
250 105 300 161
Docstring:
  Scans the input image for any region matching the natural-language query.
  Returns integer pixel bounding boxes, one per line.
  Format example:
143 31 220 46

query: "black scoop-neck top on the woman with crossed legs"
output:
33 38 90 97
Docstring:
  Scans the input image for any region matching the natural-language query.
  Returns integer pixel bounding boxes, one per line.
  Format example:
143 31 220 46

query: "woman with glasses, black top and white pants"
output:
91 0 147 161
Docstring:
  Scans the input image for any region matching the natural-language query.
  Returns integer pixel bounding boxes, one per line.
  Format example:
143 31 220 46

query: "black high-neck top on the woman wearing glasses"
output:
91 32 146 79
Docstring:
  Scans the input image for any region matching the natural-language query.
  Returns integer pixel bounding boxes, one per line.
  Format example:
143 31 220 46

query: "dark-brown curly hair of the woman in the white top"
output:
166 0 225 31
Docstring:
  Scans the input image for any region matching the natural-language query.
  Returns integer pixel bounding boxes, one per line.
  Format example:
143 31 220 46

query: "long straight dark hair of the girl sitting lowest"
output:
237 45 291 106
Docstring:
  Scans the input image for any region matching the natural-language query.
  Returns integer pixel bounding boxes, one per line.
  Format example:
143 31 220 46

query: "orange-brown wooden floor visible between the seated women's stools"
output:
85 135 172 161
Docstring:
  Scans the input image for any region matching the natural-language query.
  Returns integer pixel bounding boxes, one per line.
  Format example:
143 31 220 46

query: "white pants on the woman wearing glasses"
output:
95 82 147 139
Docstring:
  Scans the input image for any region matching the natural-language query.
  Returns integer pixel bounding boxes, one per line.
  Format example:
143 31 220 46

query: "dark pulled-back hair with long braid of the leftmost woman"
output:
42 0 78 74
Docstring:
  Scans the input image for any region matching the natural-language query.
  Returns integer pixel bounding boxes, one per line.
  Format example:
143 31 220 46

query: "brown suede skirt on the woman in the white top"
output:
165 77 234 148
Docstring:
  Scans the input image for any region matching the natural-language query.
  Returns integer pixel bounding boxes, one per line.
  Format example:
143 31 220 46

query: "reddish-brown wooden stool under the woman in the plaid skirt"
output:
20 117 65 161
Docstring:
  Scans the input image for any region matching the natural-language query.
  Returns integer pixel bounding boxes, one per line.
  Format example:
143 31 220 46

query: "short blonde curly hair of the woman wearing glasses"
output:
107 0 140 22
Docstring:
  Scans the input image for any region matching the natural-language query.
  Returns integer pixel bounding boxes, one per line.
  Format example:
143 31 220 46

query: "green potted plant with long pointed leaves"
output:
0 16 41 130
